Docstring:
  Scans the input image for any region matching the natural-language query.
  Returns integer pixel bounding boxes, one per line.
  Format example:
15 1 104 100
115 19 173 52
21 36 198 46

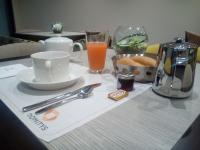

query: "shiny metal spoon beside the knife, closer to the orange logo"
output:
35 87 94 115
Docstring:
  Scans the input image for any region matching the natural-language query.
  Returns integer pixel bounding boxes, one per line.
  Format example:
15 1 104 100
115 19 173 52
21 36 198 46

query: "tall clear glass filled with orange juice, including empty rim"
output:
86 32 108 73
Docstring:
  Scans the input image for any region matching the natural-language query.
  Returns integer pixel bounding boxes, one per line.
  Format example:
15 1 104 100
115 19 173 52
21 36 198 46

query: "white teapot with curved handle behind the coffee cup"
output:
39 36 83 61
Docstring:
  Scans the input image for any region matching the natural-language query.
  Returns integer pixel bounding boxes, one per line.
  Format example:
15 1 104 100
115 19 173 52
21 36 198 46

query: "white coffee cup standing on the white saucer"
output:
31 51 70 82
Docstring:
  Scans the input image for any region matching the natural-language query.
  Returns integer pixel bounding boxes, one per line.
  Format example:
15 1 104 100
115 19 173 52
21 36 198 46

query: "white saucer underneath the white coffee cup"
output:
17 68 81 90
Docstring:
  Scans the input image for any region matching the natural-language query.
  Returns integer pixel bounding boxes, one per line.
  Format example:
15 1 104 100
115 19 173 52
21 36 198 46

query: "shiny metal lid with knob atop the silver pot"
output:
164 37 198 51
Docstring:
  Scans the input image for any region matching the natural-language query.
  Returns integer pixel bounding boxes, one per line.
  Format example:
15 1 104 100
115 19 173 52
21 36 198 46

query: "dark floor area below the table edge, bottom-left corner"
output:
0 100 46 150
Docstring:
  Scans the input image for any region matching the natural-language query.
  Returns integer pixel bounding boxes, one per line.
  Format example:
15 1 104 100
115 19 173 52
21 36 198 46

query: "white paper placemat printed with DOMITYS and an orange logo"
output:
0 64 151 142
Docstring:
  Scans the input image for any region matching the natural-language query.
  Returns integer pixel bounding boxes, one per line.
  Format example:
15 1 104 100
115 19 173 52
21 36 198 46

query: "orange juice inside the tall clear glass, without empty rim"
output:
87 42 107 72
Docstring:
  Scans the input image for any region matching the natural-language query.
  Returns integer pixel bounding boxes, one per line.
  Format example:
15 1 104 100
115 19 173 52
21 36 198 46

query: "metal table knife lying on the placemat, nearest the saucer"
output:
22 83 101 112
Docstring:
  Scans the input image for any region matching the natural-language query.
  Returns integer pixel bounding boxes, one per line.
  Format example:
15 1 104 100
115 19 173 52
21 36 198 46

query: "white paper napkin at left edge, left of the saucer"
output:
0 64 27 79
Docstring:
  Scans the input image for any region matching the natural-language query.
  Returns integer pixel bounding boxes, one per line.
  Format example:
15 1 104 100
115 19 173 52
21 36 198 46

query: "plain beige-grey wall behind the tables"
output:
13 0 200 42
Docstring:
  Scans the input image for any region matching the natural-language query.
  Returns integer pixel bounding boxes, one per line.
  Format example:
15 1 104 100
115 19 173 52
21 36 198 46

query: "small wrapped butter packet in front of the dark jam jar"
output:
108 90 128 101
